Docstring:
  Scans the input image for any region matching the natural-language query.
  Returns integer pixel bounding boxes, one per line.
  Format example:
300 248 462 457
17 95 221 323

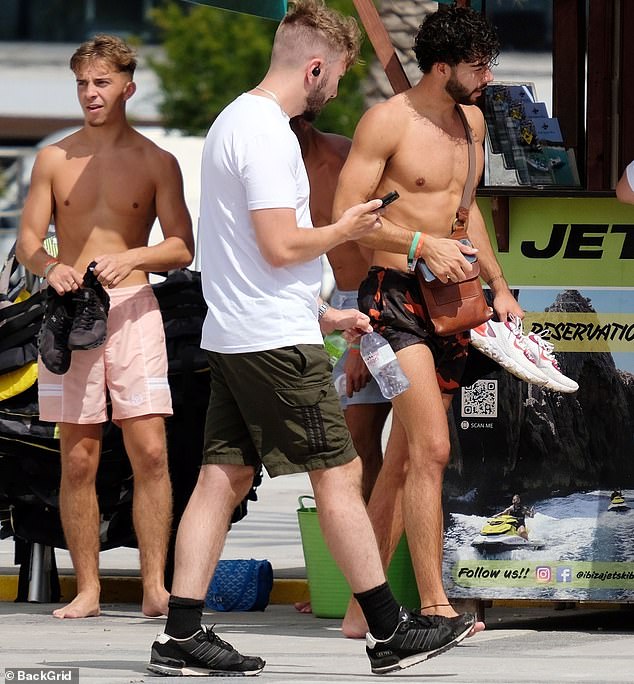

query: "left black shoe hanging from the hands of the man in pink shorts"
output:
37 286 75 375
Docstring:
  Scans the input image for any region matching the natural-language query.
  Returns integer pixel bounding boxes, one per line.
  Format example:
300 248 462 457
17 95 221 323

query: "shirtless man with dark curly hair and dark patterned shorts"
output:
334 7 523 637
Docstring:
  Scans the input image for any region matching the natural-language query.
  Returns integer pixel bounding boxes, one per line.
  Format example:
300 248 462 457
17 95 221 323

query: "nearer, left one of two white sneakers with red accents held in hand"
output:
471 321 549 386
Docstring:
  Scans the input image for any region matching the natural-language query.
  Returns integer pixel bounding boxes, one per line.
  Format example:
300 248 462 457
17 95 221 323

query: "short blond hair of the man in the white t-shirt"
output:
271 0 361 69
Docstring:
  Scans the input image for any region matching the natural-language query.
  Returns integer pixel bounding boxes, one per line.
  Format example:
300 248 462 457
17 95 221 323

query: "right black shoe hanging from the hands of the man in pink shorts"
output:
68 262 110 350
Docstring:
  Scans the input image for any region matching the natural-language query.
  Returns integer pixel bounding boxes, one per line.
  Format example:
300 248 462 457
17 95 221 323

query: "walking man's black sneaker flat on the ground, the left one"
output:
147 625 264 677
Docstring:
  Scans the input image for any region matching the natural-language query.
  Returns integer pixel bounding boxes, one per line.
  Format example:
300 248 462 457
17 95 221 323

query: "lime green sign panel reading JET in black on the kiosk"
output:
478 197 634 289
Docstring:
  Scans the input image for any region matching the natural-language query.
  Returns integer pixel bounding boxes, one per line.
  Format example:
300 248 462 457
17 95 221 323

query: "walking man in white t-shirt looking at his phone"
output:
148 0 474 675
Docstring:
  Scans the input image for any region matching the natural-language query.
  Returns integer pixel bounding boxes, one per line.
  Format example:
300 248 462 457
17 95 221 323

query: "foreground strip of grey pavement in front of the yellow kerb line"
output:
0 603 634 684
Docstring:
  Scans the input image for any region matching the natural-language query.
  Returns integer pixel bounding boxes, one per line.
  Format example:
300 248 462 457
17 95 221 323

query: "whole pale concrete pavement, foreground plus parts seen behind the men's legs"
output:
0 475 634 684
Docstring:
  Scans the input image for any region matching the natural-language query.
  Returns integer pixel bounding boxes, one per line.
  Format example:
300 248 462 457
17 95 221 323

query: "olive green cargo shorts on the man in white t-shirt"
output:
202 344 356 477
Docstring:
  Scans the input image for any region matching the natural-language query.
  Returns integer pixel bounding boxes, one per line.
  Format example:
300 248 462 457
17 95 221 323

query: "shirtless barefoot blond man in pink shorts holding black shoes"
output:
17 35 194 618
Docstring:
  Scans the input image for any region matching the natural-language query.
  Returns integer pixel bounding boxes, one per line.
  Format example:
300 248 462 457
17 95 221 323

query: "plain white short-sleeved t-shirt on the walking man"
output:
198 93 322 354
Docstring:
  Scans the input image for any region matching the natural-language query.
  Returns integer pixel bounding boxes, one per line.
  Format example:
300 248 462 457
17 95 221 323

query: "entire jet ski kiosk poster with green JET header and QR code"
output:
443 192 634 602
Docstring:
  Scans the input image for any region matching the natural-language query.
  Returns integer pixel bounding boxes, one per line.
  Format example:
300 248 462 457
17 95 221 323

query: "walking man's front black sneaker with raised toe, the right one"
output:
365 608 475 674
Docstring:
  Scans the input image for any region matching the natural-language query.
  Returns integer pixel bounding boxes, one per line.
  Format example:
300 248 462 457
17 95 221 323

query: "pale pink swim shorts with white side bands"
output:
38 285 172 424
